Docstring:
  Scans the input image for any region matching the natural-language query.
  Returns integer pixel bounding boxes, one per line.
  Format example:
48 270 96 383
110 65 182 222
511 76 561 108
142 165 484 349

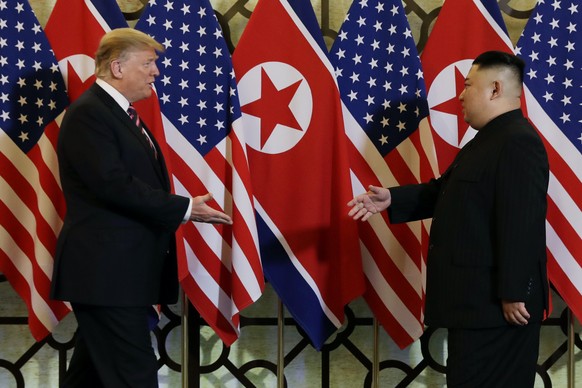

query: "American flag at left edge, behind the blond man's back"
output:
0 0 70 341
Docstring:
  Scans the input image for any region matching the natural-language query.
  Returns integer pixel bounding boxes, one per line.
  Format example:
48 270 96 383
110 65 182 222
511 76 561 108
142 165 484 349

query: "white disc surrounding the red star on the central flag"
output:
238 62 313 154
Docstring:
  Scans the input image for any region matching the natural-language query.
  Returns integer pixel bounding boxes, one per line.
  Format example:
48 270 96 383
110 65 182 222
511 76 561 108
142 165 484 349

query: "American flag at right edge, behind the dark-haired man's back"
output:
516 0 582 320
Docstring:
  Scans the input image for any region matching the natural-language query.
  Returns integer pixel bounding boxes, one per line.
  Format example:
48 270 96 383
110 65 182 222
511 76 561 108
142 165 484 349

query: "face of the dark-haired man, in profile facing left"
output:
459 65 495 130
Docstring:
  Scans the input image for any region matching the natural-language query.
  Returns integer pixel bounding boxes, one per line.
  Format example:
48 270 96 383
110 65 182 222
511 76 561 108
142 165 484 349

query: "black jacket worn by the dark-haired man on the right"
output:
388 110 549 328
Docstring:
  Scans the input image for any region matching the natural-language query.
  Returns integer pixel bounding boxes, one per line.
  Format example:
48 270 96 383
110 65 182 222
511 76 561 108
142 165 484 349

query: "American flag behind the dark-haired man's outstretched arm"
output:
330 0 432 348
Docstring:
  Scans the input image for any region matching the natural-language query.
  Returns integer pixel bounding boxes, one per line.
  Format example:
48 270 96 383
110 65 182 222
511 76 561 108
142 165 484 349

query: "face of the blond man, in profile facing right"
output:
119 48 160 102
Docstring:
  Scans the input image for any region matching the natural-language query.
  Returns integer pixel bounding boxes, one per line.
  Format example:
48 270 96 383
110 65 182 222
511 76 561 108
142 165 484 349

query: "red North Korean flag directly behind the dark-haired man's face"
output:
421 0 513 175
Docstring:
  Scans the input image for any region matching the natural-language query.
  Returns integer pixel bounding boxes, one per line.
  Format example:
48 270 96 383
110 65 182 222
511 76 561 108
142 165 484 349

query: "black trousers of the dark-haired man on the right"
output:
447 323 541 388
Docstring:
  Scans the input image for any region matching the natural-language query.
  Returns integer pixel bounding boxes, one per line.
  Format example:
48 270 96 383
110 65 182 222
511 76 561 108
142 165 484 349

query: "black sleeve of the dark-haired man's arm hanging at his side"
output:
493 132 548 302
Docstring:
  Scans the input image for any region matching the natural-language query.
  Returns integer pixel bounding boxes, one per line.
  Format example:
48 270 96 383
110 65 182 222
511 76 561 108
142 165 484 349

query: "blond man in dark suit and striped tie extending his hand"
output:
51 28 232 388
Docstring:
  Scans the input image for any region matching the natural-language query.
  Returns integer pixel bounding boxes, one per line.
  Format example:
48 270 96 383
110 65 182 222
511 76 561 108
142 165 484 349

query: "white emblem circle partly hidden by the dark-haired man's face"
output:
427 59 477 148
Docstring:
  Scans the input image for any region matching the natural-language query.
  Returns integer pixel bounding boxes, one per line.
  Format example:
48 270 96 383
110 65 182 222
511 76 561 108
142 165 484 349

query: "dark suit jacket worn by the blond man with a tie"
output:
51 84 189 306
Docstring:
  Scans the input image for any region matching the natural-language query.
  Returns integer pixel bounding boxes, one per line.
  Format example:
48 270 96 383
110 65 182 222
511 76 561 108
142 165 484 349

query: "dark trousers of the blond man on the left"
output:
61 304 158 388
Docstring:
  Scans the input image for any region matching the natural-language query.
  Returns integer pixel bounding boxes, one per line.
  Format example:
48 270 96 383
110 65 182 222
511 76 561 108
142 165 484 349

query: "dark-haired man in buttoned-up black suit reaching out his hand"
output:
348 52 549 388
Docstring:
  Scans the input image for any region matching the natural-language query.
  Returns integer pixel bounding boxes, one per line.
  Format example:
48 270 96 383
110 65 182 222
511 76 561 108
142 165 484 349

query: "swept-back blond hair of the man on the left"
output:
95 28 164 79
